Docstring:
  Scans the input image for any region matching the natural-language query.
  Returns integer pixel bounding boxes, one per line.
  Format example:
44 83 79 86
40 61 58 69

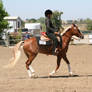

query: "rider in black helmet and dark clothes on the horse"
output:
45 9 58 55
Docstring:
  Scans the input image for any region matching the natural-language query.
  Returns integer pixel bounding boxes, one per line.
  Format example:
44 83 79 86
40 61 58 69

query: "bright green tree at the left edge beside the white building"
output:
0 0 8 34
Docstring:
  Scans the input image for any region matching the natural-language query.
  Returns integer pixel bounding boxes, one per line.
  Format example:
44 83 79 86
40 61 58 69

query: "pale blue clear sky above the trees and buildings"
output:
2 0 92 20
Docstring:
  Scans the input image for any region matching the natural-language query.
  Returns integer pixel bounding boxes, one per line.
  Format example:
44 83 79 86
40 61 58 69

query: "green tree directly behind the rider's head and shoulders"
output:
52 11 63 29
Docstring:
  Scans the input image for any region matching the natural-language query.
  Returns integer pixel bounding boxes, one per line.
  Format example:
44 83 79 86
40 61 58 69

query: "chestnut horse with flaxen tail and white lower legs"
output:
5 24 84 77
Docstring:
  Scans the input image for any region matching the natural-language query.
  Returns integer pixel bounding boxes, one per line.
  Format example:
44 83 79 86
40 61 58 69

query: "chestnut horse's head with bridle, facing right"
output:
71 24 84 39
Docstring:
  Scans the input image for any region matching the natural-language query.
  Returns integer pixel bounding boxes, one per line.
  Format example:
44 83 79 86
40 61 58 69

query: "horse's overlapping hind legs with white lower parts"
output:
26 54 36 77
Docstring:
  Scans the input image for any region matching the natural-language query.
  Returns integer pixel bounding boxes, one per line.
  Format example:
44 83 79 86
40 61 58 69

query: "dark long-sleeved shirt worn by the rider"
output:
45 18 56 34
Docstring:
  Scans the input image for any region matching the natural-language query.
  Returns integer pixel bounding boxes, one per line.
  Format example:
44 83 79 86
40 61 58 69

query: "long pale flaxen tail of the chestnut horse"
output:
4 41 23 68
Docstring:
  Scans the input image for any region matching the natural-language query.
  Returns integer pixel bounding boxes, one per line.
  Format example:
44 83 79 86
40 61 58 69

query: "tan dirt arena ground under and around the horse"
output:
0 45 92 92
